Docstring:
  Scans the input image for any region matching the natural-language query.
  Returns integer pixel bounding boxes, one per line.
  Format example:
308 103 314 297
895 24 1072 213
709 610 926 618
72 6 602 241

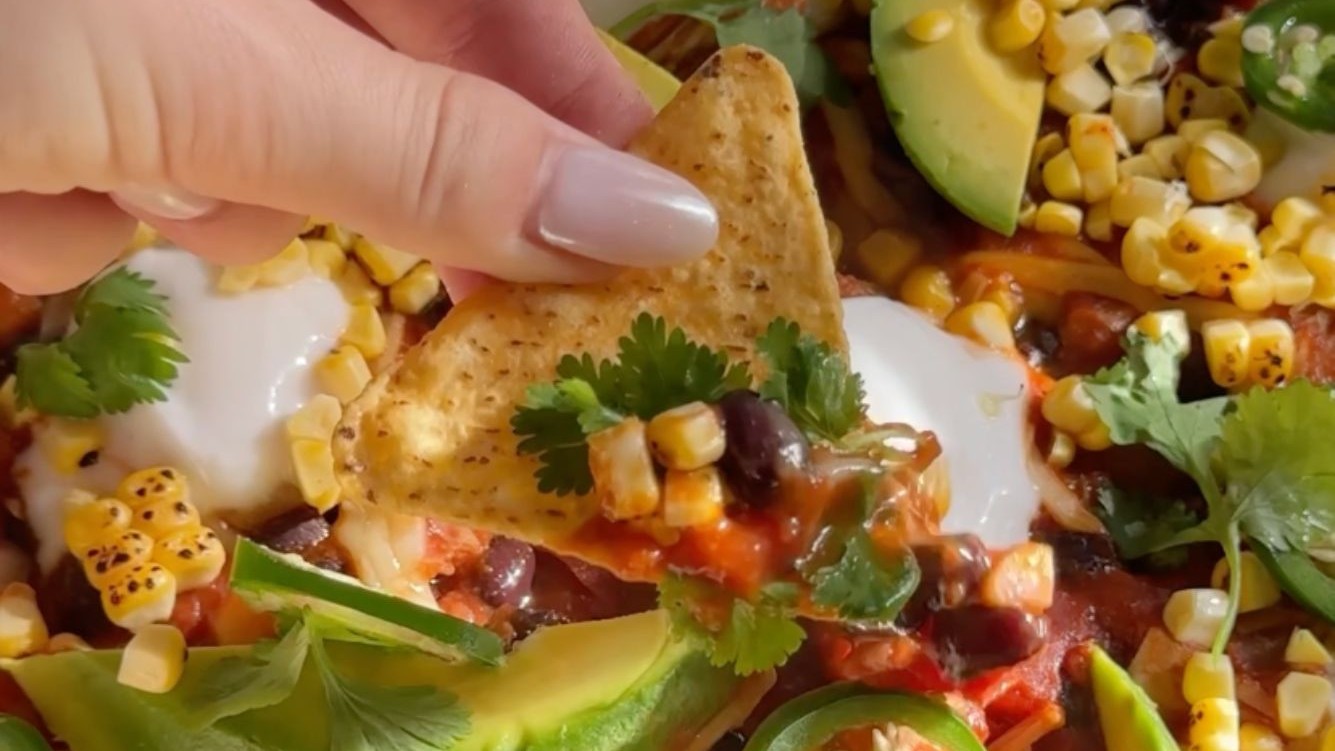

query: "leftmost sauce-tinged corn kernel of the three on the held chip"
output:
589 418 662 522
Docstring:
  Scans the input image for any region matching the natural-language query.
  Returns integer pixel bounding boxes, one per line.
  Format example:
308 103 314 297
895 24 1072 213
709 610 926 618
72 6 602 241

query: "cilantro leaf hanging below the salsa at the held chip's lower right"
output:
810 526 921 620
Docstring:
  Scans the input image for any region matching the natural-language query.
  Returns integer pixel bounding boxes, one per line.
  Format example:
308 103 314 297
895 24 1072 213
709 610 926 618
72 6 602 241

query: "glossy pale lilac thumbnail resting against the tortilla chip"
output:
538 147 718 267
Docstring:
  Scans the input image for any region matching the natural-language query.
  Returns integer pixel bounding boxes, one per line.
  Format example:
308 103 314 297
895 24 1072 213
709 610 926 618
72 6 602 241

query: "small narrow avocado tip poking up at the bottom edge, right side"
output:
1089 647 1177 751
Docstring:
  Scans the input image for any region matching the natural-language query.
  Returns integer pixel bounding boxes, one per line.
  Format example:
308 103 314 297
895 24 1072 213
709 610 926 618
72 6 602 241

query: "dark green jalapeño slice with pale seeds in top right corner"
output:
1243 0 1335 132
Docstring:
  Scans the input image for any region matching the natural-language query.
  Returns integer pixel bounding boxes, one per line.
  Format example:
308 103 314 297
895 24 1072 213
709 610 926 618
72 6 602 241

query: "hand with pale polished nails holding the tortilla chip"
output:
0 0 717 300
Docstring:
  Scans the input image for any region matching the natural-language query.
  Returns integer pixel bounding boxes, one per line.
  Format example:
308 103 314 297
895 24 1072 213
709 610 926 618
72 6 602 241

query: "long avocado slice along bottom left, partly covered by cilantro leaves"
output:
5 612 740 751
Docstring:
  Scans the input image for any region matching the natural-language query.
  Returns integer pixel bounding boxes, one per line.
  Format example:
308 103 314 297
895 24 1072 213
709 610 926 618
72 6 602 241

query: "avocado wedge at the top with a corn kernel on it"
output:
872 0 1045 235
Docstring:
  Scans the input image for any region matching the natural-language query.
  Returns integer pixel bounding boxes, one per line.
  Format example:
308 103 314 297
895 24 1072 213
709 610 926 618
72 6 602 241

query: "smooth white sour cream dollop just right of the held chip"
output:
844 297 1039 547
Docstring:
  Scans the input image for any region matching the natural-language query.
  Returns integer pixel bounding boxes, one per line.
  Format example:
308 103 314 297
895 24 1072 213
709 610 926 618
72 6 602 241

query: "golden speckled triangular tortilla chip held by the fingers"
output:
334 47 848 578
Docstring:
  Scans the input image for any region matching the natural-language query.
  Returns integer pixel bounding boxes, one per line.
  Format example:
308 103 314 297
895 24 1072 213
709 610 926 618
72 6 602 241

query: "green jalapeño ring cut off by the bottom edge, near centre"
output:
744 683 984 751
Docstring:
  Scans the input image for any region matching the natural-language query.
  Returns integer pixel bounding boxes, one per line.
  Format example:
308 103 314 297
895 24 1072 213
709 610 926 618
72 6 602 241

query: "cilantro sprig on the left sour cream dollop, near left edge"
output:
16 267 190 419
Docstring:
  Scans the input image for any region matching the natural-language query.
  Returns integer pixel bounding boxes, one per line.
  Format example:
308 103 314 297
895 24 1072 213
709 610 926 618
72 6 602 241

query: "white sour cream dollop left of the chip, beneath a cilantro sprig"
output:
16 248 348 568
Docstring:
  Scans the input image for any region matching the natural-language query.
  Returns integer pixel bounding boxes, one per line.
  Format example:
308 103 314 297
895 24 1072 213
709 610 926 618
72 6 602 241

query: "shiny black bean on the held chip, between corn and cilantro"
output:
718 391 810 506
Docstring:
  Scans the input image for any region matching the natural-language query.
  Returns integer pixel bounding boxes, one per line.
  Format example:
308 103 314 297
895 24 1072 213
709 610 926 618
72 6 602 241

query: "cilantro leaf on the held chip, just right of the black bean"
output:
756 319 866 443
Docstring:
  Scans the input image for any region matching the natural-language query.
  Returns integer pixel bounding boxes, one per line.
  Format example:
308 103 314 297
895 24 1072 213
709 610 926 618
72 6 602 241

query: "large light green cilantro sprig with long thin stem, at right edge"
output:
1085 329 1335 654
